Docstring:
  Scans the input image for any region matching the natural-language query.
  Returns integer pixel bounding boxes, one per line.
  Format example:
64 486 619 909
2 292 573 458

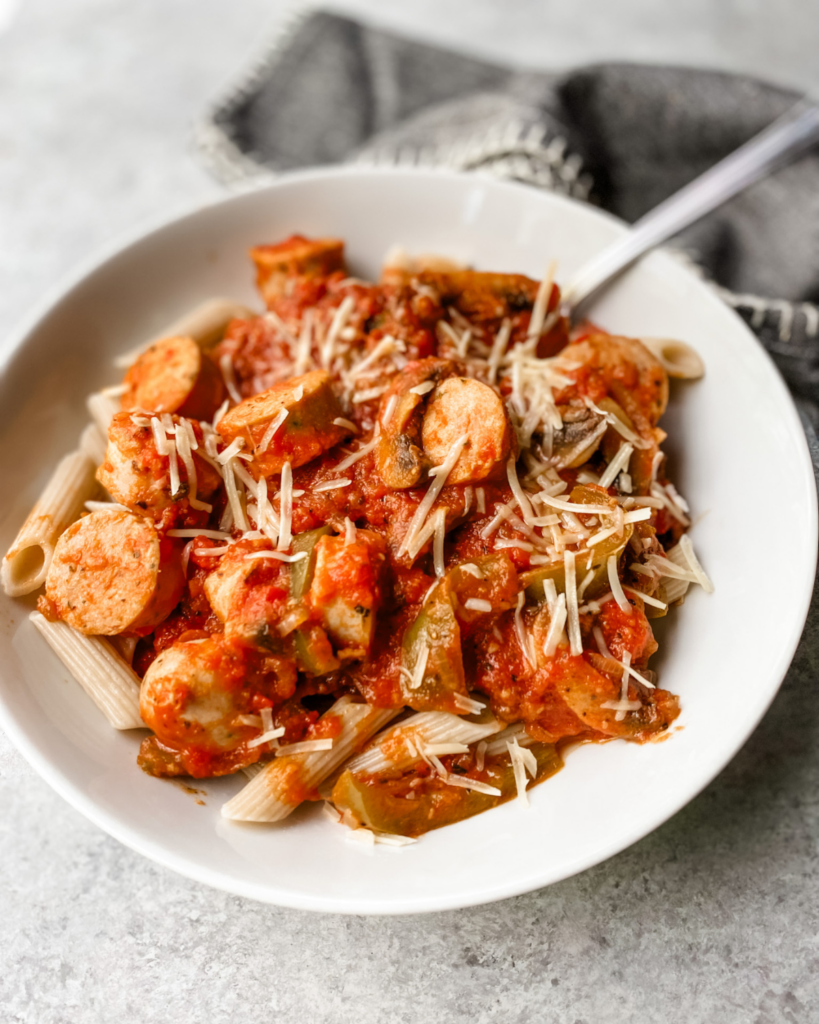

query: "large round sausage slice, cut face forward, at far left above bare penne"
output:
45 511 185 636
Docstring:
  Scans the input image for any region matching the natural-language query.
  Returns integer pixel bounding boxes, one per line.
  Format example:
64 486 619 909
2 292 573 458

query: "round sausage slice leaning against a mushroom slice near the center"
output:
422 377 514 484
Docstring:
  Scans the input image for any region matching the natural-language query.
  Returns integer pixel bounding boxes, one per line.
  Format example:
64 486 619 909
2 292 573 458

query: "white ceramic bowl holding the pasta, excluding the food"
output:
0 170 817 913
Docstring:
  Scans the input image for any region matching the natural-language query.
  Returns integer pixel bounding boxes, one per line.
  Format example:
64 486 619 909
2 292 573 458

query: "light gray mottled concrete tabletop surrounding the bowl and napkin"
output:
0 0 819 1024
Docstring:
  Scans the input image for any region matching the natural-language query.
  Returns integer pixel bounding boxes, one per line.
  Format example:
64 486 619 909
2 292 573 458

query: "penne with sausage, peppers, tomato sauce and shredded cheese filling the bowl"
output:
2 236 713 845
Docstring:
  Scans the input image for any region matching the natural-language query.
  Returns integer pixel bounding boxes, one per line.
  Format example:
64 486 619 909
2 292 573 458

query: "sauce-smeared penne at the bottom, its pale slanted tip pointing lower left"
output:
222 697 400 821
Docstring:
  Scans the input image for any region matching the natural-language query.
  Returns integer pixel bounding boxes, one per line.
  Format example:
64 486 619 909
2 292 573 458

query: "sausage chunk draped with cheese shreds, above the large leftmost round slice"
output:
96 413 221 517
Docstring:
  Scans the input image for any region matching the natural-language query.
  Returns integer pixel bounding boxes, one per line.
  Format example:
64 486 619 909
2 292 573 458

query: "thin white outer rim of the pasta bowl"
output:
0 166 819 915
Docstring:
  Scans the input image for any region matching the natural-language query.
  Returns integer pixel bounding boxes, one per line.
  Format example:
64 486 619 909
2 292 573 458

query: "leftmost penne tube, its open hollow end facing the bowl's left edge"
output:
0 452 101 597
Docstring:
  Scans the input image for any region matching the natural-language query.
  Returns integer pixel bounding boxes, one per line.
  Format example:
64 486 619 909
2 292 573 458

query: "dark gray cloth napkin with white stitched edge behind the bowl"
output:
198 4 819 439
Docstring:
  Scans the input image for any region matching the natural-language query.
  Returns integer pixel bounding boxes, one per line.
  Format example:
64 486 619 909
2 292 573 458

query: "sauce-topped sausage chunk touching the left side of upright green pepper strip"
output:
205 540 292 654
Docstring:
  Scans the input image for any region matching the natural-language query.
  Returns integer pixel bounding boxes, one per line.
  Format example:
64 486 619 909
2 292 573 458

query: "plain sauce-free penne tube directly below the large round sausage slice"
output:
30 611 144 729
